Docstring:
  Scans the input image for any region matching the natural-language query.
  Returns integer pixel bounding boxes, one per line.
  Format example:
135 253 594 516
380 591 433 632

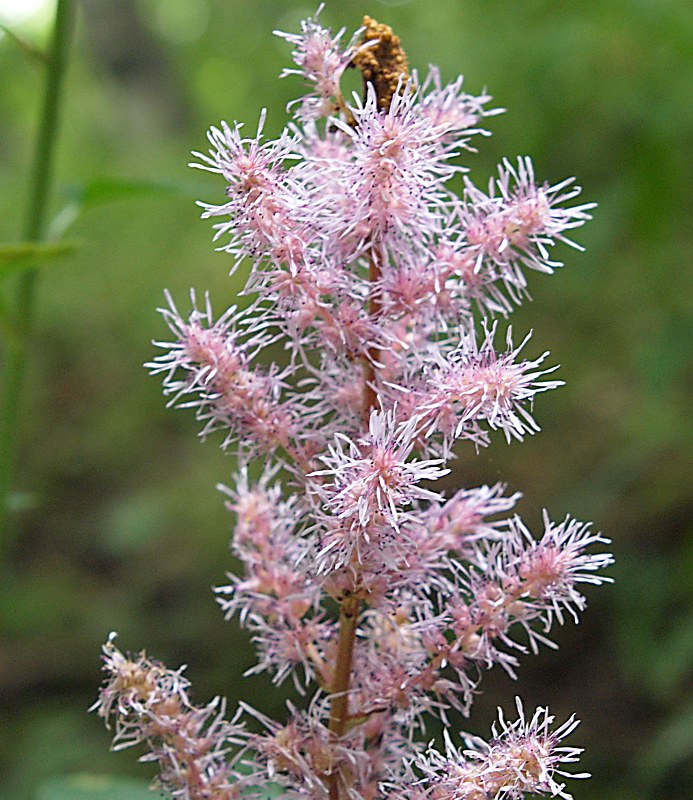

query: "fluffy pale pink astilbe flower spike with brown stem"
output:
95 7 611 800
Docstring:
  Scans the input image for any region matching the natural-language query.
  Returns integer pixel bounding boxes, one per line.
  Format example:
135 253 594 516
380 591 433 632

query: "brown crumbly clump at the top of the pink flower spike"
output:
353 16 409 111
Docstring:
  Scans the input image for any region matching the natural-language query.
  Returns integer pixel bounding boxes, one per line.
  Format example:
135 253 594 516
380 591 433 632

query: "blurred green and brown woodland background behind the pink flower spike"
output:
0 0 693 800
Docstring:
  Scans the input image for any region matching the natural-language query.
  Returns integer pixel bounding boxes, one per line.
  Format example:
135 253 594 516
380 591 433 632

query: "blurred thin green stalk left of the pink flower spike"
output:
0 0 73 554
